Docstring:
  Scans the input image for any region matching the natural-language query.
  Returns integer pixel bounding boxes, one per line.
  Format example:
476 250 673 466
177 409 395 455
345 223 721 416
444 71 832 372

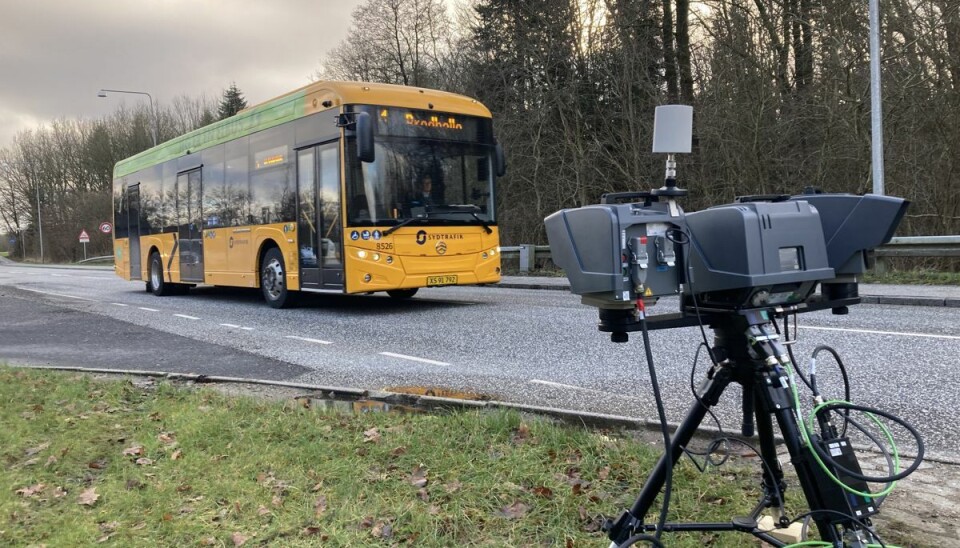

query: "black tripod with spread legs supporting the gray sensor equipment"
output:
604 310 875 546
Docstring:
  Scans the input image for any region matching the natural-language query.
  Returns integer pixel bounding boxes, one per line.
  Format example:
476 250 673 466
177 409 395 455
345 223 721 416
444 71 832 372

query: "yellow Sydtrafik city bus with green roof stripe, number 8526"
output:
113 82 504 308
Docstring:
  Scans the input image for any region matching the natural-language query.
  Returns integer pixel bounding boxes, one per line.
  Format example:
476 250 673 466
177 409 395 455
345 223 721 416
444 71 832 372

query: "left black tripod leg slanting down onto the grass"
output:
605 367 733 544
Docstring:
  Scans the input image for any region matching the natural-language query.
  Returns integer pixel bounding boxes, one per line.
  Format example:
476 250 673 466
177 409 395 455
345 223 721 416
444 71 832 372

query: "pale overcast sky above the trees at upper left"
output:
0 0 360 148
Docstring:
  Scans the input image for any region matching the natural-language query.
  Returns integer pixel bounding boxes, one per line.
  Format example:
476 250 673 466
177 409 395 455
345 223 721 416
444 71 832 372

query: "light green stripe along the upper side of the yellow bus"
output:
113 90 306 178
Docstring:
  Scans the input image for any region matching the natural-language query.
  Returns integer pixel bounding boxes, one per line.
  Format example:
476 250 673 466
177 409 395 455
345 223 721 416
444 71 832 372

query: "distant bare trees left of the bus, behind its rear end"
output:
0 90 246 262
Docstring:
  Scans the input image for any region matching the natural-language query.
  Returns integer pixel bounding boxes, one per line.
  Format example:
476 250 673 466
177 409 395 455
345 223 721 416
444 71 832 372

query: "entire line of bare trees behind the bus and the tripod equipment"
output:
0 0 960 266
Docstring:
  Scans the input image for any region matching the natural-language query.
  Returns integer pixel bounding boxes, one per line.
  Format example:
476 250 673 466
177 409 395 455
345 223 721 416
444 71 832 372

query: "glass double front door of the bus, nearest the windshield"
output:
297 141 343 289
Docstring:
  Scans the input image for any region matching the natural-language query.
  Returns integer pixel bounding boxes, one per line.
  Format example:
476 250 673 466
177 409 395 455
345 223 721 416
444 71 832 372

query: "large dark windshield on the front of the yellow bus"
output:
346 128 496 226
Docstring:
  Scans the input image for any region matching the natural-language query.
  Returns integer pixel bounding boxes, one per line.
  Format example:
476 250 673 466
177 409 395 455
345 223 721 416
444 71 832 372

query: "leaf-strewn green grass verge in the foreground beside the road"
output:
0 367 864 547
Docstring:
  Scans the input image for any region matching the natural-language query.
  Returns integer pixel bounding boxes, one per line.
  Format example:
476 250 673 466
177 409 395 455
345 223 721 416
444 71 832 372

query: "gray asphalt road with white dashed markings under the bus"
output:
0 264 960 459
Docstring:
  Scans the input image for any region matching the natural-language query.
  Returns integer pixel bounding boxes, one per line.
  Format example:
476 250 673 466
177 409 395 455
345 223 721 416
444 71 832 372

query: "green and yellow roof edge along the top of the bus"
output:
113 81 490 178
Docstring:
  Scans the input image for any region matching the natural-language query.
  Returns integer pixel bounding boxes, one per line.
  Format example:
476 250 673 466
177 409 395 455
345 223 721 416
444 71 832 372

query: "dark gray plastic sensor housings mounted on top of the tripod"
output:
545 194 908 310
